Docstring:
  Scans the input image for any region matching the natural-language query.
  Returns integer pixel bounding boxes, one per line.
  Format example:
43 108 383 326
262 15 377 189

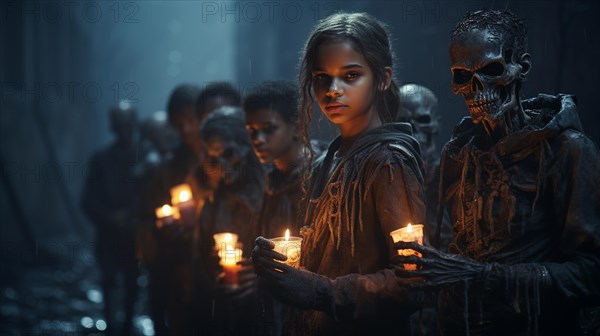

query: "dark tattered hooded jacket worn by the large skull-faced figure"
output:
440 95 600 335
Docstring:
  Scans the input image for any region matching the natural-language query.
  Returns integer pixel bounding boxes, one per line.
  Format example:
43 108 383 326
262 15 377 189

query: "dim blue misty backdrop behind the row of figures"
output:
0 1 600 334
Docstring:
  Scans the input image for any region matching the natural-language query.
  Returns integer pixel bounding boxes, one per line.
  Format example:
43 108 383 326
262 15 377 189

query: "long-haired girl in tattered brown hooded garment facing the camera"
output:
253 13 425 334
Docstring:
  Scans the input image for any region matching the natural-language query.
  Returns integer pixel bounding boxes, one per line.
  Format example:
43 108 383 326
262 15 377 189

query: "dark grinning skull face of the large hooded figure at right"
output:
450 29 530 128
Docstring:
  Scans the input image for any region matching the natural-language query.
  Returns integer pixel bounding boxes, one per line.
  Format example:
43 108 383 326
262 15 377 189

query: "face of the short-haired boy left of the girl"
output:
246 109 296 163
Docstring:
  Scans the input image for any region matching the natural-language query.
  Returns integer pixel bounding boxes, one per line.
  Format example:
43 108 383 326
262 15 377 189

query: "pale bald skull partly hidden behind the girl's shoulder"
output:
397 84 440 158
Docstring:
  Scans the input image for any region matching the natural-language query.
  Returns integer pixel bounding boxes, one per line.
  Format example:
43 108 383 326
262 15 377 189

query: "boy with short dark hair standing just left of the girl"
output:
243 81 322 335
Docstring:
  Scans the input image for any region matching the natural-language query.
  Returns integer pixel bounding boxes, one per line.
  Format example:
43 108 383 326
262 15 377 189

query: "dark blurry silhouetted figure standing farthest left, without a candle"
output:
82 102 139 334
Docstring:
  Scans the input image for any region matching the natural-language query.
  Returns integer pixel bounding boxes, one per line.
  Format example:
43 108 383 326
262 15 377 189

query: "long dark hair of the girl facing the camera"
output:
299 13 400 156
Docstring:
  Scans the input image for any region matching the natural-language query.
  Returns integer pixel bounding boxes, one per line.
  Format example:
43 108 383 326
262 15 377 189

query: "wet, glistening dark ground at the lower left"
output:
0 253 154 336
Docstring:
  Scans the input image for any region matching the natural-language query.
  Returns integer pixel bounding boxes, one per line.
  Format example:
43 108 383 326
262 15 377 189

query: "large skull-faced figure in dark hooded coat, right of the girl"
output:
396 10 600 335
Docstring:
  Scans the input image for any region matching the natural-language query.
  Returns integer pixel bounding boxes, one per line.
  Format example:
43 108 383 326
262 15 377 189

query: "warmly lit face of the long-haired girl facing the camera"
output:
313 40 376 127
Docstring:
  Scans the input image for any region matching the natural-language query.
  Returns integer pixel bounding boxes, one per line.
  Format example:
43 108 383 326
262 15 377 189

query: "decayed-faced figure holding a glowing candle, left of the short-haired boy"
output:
195 106 264 335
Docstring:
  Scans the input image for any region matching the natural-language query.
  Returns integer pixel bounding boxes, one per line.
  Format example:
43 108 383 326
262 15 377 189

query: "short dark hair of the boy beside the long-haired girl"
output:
243 80 299 125
